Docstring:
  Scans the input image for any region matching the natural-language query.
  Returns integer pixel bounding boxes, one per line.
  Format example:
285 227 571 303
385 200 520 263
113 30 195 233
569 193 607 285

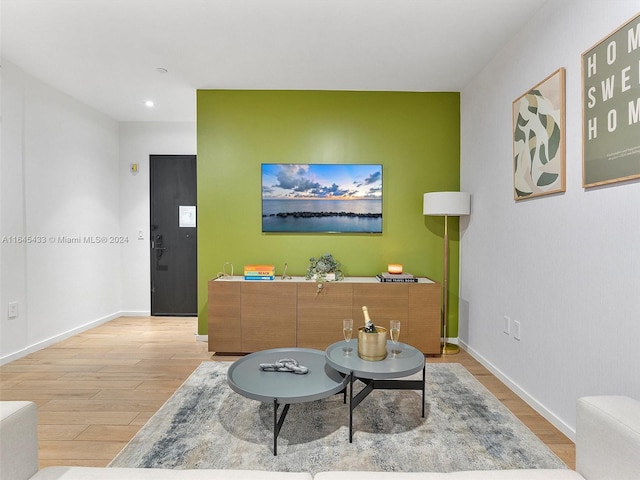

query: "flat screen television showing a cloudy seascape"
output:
262 163 382 233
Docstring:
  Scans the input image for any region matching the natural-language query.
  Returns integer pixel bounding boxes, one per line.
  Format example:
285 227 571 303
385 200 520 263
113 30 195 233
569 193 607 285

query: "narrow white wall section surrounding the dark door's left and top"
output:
120 122 196 315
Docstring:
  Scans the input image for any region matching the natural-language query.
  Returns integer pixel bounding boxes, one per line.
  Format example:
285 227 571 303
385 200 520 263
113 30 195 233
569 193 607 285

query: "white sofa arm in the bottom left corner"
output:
0 402 38 480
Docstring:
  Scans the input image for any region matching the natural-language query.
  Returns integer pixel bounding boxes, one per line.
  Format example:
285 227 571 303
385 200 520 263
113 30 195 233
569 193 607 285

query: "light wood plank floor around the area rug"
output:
0 317 575 468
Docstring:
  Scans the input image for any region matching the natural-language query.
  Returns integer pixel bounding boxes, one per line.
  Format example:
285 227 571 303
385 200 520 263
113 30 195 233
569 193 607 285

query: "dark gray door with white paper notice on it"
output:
149 155 198 316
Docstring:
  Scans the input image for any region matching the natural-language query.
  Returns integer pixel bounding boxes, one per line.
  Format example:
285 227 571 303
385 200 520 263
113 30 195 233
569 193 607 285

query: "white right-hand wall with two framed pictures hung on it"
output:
460 0 640 438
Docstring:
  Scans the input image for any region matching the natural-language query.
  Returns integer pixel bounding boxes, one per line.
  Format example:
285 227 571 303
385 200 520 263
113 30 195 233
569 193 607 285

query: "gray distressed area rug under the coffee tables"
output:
109 361 567 474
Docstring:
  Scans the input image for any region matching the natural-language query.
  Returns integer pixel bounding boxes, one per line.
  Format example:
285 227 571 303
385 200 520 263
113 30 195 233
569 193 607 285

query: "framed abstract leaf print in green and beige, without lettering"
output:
513 68 566 200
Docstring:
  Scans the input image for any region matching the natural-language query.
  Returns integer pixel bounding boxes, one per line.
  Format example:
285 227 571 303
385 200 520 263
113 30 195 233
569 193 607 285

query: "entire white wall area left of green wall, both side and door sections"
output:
0 61 196 363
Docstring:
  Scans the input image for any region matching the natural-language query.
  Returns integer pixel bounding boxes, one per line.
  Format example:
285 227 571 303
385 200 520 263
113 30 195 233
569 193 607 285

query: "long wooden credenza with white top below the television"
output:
208 276 441 354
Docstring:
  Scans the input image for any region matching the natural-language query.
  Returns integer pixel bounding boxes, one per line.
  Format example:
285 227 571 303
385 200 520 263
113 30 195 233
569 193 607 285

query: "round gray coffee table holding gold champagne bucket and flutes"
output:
325 340 426 442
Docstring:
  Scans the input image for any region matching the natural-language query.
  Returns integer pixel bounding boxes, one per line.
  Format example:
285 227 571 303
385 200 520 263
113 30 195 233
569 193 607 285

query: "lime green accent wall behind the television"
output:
197 90 460 336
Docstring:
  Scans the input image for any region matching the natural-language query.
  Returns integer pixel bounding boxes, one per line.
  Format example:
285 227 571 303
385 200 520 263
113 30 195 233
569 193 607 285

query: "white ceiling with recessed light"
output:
0 0 546 121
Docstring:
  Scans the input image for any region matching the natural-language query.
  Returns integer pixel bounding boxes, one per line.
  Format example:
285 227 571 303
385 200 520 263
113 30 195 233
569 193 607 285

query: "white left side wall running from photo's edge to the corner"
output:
0 61 121 362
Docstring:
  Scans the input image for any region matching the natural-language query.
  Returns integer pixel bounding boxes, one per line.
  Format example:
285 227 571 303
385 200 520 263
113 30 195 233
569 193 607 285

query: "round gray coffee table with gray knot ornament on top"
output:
227 348 348 455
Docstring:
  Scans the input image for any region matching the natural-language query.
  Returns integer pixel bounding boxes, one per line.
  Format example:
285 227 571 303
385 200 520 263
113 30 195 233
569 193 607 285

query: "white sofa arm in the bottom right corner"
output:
576 396 640 480
